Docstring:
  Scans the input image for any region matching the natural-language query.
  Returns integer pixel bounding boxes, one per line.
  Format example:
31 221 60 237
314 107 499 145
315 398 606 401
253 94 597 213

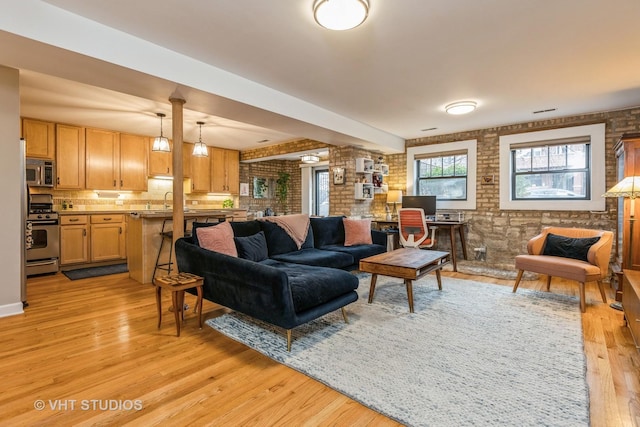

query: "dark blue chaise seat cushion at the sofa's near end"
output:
263 259 358 313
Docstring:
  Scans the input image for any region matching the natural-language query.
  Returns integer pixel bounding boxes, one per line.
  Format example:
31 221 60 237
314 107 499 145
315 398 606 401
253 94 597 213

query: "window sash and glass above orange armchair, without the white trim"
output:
511 138 591 200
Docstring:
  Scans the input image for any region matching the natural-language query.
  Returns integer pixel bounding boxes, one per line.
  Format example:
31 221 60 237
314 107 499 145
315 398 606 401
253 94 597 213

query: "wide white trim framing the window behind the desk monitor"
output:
406 139 478 210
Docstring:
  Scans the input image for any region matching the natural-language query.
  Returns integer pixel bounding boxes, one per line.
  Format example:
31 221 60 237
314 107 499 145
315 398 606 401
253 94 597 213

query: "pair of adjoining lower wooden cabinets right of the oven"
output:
60 214 127 266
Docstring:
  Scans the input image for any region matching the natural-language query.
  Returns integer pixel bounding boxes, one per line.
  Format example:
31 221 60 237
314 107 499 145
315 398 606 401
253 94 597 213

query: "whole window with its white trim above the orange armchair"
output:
500 124 605 211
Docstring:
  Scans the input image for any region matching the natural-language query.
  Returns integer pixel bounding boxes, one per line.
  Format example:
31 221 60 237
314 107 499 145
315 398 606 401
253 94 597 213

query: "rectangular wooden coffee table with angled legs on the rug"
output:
360 248 451 313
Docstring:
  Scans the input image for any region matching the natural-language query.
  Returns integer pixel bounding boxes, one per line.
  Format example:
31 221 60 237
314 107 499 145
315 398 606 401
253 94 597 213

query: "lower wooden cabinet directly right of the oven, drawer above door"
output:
60 215 90 266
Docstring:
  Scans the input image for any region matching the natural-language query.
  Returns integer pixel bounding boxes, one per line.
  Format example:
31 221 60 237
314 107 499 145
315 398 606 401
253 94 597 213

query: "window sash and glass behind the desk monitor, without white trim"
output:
416 151 468 200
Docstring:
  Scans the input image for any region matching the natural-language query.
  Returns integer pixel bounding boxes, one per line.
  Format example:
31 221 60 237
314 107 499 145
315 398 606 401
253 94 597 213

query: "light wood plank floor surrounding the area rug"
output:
0 273 640 426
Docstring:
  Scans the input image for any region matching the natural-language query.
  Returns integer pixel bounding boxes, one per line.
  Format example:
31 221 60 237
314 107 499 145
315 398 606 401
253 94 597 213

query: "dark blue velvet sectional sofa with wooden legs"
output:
175 217 386 350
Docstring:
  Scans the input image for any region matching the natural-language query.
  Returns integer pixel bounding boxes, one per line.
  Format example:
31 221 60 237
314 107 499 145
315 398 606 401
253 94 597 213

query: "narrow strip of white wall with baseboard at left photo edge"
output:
0 66 24 317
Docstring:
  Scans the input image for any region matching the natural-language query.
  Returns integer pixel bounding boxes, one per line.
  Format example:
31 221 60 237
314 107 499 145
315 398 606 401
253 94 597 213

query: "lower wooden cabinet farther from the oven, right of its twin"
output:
90 214 127 262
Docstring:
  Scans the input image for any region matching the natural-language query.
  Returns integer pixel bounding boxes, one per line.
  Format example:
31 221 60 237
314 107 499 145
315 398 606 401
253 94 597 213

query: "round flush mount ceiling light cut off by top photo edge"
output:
313 0 369 31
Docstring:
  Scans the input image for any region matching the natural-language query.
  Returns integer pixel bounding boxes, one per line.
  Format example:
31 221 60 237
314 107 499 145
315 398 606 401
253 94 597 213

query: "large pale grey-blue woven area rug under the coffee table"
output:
207 274 589 426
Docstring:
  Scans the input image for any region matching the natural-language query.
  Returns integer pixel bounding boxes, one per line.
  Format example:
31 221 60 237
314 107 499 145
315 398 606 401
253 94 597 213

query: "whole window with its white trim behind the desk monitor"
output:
405 139 477 209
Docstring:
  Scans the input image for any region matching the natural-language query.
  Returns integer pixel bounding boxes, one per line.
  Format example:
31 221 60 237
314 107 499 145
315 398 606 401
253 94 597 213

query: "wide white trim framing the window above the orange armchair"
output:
500 123 606 211
